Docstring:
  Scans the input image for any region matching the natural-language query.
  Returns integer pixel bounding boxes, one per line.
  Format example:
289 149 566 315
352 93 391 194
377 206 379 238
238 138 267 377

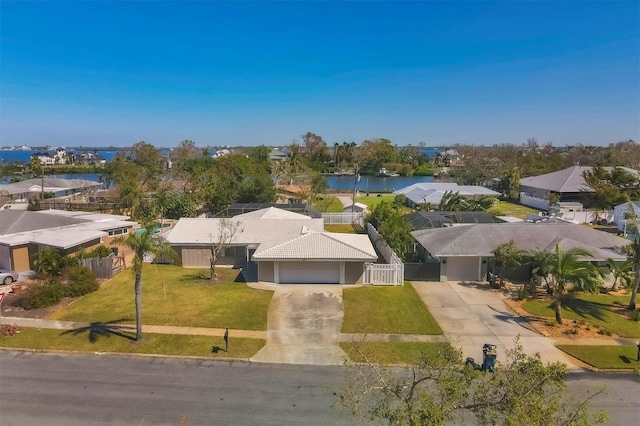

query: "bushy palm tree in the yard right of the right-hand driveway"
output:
550 245 600 324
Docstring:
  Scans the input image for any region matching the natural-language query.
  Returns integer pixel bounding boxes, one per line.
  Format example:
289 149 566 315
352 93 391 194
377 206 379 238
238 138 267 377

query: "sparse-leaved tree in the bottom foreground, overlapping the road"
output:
336 338 607 426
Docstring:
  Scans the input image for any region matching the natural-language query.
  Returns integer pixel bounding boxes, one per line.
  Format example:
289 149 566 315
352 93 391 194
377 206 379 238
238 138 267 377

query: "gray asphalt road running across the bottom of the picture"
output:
0 351 640 426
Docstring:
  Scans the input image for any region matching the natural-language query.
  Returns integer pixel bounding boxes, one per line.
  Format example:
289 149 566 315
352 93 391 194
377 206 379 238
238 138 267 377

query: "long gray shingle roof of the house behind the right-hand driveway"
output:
411 222 629 260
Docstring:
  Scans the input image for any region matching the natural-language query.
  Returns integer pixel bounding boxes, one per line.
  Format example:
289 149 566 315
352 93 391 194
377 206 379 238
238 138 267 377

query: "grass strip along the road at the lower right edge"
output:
558 345 640 369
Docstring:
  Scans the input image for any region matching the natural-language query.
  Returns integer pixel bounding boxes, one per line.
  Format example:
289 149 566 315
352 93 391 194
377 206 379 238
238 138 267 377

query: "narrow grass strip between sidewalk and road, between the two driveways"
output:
340 342 449 364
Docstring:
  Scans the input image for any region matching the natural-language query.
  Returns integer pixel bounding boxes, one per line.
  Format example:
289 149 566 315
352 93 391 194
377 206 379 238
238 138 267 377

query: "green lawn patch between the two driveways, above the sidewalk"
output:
342 283 442 334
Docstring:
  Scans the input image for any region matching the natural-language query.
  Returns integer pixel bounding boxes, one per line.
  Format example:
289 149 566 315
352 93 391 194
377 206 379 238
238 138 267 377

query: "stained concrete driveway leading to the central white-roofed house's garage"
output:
251 284 346 365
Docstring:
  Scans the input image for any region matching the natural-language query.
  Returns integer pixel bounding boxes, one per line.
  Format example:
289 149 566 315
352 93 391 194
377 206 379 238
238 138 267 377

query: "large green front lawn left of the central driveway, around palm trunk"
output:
50 264 273 330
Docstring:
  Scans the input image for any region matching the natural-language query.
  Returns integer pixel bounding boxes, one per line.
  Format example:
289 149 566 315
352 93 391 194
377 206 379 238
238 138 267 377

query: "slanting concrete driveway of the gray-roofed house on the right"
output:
413 281 580 370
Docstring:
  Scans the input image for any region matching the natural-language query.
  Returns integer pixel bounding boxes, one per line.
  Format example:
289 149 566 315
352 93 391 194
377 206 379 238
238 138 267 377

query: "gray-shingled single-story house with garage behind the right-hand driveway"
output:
411 222 629 281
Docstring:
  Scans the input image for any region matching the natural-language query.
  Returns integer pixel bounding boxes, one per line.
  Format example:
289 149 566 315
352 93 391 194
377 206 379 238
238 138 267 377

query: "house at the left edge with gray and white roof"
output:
0 209 137 273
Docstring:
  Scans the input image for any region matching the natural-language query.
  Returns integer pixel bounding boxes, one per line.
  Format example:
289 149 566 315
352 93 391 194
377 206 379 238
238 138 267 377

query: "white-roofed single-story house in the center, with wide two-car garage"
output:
165 207 378 284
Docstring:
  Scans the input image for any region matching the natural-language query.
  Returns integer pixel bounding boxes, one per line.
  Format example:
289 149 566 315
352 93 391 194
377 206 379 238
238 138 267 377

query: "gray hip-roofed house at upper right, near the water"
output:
520 166 640 210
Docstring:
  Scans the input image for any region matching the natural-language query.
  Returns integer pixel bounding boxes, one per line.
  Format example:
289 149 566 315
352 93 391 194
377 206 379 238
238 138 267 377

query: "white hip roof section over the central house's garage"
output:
252 232 378 261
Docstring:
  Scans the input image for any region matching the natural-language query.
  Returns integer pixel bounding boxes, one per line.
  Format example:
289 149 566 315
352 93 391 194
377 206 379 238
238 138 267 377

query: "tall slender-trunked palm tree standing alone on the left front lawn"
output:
114 224 177 342
